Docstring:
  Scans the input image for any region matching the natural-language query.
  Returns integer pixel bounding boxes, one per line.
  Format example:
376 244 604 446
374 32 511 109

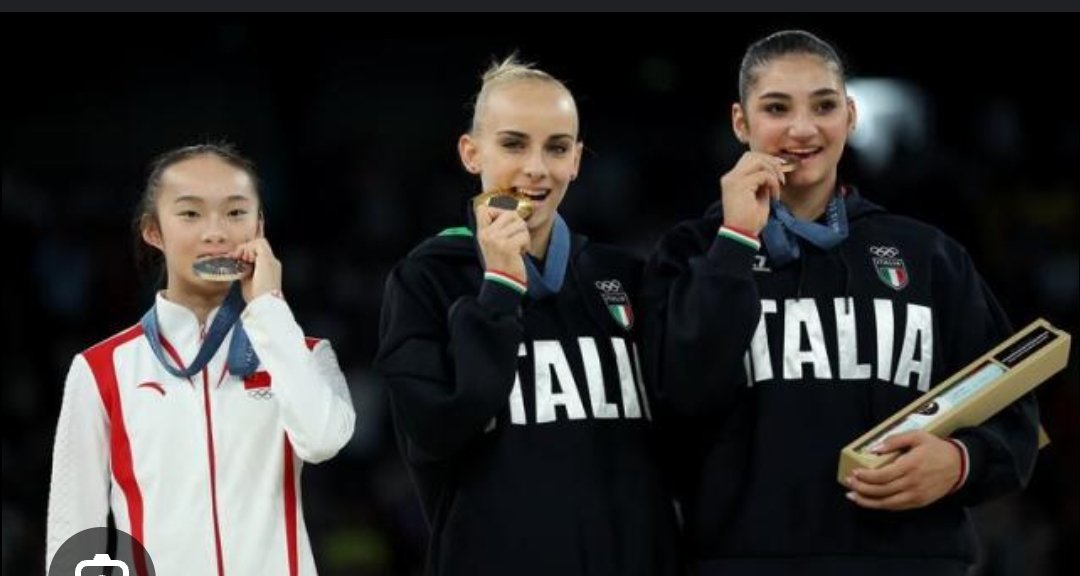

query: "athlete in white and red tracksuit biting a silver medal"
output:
46 145 355 576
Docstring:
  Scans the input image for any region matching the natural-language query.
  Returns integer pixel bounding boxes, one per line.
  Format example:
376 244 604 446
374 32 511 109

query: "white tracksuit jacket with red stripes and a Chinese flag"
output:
46 294 355 576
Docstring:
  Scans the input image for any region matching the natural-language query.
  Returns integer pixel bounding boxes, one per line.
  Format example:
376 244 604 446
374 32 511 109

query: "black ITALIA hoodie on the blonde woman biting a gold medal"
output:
376 228 677 576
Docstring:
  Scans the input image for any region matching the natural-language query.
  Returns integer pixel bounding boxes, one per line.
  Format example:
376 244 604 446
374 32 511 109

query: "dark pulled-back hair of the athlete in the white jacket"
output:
132 142 261 285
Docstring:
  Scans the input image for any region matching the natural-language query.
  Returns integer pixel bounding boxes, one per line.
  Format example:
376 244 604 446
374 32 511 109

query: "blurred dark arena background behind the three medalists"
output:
2 14 1080 575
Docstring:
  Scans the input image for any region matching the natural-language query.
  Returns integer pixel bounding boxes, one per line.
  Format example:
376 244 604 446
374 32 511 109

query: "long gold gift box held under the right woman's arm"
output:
836 318 1071 484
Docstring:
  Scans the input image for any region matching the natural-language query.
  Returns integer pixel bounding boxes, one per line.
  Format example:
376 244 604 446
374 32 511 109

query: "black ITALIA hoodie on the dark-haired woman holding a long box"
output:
642 191 1038 576
